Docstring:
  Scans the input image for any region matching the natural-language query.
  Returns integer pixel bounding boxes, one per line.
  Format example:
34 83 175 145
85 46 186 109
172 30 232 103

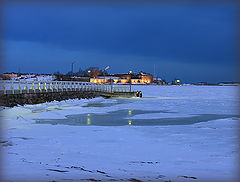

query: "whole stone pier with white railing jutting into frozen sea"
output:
0 81 140 107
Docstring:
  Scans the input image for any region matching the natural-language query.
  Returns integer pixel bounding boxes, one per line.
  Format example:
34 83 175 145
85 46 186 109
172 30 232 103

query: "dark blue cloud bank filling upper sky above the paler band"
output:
3 4 236 64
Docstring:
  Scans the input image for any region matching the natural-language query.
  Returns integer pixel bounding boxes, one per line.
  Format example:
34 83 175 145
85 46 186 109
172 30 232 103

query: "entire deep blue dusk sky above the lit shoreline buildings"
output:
3 3 237 82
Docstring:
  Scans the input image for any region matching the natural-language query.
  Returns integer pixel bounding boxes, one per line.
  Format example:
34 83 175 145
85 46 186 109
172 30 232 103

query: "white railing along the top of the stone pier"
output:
0 80 130 94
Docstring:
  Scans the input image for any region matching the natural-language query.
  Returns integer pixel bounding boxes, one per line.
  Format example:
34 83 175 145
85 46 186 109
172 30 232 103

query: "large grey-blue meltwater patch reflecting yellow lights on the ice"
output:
35 109 238 126
